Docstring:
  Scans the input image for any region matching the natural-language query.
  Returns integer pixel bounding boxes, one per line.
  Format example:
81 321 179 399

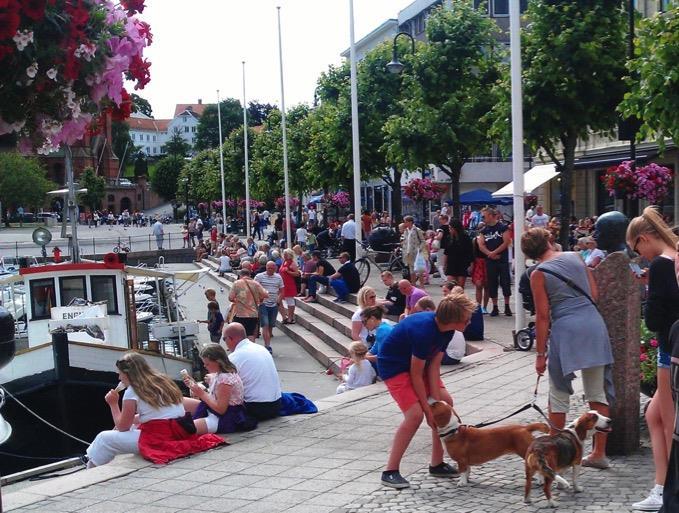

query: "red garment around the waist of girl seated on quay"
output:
139 419 226 463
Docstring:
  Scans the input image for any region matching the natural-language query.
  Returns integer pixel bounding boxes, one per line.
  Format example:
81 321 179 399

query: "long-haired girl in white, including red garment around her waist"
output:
87 353 224 468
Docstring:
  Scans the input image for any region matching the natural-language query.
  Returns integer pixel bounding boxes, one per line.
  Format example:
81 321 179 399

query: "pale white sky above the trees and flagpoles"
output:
134 0 412 119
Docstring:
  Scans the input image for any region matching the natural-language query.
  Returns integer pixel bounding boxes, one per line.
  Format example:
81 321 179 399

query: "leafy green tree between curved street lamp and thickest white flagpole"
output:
385 0 502 215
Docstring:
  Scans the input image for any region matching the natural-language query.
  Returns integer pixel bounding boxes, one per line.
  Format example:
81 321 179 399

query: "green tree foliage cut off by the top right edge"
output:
621 6 679 147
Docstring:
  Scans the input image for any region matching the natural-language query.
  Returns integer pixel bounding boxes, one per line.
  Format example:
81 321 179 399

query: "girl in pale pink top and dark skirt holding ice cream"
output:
184 344 257 435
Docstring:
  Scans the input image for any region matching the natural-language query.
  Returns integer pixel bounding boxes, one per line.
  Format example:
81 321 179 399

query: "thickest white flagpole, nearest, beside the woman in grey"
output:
509 0 526 331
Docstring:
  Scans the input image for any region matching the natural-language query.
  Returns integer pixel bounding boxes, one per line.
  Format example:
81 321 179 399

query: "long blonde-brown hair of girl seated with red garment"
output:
116 353 182 408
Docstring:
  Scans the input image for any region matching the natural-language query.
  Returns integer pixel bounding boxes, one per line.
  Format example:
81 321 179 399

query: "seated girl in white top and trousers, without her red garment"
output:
87 353 184 468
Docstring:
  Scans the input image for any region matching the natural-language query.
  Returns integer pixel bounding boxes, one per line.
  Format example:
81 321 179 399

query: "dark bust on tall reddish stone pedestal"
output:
594 211 641 454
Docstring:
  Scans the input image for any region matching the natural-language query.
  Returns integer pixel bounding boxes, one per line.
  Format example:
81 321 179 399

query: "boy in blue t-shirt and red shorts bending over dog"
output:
377 294 476 488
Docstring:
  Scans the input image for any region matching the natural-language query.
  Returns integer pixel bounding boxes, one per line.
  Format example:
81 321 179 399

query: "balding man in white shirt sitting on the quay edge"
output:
224 322 281 420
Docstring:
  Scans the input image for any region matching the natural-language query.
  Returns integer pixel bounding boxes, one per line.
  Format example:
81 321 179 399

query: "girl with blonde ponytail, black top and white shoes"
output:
626 207 679 511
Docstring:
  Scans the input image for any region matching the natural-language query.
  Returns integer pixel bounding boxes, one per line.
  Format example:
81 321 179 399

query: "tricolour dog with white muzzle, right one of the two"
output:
523 410 611 508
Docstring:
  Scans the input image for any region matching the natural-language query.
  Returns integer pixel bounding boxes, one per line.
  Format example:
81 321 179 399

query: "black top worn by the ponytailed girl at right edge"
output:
644 256 679 353
